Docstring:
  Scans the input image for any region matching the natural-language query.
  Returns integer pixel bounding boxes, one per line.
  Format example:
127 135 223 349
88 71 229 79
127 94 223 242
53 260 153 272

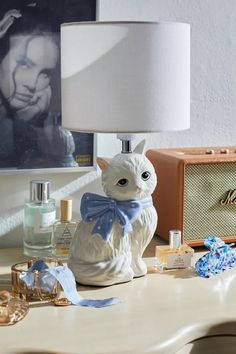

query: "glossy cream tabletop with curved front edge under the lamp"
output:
0 241 236 354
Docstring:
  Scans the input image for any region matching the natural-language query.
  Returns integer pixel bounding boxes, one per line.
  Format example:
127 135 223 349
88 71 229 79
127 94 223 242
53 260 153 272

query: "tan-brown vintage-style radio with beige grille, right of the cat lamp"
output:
147 147 236 246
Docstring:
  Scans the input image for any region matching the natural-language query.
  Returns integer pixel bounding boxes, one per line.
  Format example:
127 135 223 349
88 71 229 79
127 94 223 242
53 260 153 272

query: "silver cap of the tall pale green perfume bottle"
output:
30 180 50 202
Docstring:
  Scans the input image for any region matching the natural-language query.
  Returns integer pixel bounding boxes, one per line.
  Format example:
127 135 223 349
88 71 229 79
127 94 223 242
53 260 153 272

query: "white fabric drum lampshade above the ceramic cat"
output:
61 22 190 133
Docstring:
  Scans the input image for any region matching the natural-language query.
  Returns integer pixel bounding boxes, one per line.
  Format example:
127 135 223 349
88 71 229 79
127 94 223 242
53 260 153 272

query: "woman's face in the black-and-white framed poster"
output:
0 35 59 110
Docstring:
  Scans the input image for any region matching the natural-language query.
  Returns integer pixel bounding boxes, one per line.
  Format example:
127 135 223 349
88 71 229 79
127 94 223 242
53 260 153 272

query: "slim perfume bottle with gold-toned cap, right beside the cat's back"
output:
53 199 77 260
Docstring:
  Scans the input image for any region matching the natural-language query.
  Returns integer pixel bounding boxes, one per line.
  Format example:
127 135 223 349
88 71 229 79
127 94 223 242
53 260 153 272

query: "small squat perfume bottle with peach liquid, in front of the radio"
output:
155 230 194 270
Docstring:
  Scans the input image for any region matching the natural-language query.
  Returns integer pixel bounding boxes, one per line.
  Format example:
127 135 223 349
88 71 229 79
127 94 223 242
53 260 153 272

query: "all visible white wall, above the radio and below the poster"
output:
0 0 236 247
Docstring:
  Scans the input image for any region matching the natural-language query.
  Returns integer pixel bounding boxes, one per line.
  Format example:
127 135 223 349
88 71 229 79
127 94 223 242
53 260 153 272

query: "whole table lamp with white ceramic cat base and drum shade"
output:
61 22 190 285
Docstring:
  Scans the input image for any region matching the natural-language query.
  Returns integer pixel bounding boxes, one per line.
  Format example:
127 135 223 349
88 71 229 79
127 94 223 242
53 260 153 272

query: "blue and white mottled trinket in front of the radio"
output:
195 236 236 278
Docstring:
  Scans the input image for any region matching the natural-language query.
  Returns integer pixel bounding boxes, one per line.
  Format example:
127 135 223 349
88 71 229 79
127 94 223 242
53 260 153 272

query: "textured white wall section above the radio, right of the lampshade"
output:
100 0 236 155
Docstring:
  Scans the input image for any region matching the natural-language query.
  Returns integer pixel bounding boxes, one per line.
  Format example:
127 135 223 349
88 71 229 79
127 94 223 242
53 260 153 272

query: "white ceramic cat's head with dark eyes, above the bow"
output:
97 140 157 200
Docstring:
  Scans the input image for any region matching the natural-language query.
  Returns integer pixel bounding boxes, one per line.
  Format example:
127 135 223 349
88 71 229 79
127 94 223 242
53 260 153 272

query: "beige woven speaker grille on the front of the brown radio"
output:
183 163 236 241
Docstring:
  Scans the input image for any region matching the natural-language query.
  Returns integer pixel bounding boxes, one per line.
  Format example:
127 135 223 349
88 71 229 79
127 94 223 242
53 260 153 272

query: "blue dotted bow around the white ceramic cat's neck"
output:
80 193 152 241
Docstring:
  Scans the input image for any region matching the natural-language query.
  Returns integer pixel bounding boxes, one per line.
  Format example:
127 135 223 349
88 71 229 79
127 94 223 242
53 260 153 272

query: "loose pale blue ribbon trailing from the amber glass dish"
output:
20 260 121 307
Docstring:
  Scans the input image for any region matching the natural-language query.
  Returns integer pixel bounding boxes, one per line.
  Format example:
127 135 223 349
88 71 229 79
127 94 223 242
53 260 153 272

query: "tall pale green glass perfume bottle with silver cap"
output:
23 180 56 257
